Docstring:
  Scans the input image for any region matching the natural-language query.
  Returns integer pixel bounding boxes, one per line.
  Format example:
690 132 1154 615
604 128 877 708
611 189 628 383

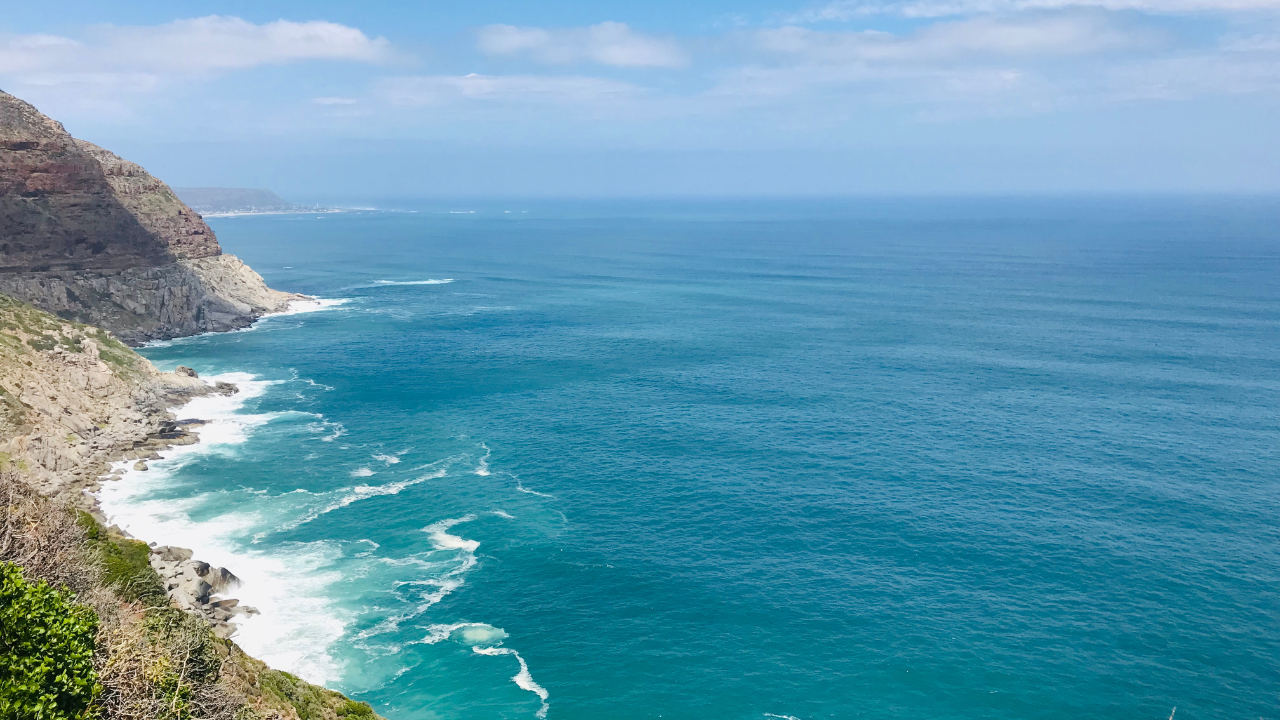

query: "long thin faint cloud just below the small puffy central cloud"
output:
376 73 644 105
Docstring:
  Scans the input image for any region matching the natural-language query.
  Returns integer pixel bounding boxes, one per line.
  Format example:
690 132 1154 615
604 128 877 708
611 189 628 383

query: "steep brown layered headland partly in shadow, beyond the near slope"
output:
0 91 303 345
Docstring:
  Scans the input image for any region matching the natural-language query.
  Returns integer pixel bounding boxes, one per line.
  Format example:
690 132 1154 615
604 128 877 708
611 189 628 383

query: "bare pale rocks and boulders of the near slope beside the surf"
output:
0 296 294 639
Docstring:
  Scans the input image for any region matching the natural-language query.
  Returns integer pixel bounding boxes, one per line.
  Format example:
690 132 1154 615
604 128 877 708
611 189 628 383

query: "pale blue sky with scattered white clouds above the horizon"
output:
0 0 1280 196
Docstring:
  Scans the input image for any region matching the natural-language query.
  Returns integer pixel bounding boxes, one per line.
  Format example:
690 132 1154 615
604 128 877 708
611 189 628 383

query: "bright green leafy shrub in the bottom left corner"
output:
0 562 99 720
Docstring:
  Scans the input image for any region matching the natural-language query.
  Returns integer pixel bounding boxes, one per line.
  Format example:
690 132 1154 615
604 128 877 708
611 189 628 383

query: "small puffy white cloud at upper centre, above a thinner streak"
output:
477 23 689 68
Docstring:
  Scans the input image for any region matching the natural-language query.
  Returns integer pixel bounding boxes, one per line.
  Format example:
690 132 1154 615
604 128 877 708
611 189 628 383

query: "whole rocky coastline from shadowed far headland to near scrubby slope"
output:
0 83 378 720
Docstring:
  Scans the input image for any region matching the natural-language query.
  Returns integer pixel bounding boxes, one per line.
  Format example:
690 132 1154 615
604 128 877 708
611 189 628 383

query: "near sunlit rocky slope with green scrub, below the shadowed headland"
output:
0 295 379 720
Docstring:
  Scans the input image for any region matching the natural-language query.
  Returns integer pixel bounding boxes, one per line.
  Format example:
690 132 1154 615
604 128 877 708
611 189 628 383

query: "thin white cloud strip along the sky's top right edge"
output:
787 0 1280 23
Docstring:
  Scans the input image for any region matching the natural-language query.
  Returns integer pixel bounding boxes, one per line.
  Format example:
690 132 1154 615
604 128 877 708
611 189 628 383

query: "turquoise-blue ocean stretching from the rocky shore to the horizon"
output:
101 197 1280 720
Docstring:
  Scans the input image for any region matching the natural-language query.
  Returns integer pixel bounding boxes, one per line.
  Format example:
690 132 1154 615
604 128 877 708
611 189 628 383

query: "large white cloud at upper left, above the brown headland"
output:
0 15 392 90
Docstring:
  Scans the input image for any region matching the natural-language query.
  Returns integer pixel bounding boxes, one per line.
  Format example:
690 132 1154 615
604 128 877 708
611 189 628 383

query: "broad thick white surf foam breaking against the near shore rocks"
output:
99 373 349 683
